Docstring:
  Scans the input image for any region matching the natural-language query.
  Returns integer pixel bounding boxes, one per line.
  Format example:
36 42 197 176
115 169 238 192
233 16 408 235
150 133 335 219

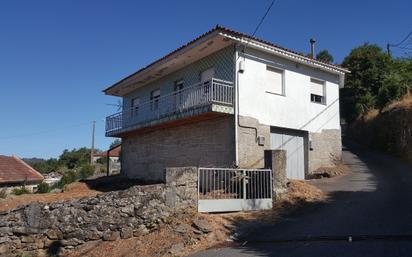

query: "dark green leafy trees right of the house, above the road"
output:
341 43 412 123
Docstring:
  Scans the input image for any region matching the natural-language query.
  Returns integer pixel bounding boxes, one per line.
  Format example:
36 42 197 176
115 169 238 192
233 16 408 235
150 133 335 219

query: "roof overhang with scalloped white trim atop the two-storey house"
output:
103 26 350 96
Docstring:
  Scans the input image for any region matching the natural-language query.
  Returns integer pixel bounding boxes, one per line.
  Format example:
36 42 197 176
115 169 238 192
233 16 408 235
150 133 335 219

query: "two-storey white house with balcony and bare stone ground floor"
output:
104 26 348 180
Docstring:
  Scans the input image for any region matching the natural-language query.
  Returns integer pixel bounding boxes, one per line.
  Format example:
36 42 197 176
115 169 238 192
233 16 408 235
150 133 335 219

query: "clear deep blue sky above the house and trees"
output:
0 0 412 158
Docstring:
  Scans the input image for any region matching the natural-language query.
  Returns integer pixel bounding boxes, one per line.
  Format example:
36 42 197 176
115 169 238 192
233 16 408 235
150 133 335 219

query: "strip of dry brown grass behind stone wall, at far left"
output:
0 182 102 211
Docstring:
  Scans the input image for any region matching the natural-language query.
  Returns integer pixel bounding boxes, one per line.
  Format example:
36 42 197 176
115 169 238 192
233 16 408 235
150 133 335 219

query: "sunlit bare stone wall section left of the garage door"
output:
238 116 270 169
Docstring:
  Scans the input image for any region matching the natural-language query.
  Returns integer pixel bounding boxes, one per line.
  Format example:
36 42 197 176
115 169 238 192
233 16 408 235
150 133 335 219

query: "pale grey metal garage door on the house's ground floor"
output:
270 129 305 179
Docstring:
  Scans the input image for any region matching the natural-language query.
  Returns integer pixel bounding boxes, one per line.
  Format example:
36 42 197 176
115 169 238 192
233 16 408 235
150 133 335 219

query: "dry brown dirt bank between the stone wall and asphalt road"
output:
67 181 326 257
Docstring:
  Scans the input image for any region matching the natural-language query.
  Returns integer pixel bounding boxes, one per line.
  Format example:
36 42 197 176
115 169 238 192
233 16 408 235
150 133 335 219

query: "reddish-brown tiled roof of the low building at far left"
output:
0 155 44 184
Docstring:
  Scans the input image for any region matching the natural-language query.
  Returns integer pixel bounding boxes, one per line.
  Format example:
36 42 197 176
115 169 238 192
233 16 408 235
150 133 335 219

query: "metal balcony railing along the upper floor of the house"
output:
106 78 234 133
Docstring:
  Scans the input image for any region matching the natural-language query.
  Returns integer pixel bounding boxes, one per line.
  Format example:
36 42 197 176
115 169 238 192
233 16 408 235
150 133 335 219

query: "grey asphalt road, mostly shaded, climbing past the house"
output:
193 144 412 257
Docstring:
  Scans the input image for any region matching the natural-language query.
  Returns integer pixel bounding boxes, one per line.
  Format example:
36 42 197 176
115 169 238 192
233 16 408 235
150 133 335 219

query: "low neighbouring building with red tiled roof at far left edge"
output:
0 155 44 192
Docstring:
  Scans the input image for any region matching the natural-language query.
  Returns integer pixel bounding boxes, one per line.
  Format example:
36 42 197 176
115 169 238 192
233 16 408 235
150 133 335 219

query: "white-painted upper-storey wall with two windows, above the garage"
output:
238 49 340 133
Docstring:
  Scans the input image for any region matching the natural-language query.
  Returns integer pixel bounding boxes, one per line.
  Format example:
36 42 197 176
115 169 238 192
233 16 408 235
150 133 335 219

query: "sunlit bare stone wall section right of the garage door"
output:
309 129 342 172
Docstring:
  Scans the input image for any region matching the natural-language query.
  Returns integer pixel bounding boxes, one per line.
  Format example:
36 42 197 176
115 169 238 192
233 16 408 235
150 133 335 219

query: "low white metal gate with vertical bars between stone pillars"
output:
198 168 272 212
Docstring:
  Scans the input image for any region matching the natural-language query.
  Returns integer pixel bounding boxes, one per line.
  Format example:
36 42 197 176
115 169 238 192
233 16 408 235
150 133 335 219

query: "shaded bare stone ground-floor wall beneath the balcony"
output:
122 115 235 181
